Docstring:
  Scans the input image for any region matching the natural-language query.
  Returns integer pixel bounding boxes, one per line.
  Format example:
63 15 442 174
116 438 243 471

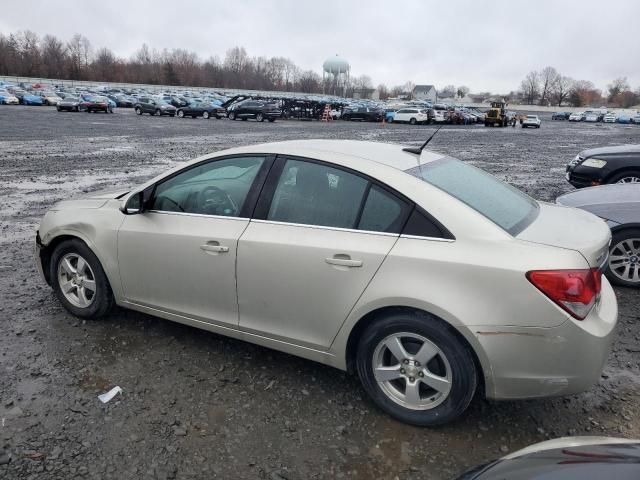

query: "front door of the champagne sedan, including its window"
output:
118 156 271 328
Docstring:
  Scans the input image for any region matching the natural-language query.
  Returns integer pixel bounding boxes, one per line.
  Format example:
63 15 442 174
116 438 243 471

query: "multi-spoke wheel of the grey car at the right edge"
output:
606 228 640 288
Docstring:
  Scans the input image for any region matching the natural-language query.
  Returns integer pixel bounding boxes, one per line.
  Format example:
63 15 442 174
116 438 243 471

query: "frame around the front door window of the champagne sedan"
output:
146 153 275 219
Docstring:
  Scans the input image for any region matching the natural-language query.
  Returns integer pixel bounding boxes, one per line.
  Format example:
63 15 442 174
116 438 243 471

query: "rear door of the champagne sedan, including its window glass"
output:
237 157 408 350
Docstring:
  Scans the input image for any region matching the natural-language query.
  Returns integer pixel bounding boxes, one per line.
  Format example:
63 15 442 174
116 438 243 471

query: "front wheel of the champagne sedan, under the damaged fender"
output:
49 239 115 318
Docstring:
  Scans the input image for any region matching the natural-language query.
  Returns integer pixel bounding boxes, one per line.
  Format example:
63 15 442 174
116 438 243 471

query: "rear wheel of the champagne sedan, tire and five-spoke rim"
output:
356 312 478 426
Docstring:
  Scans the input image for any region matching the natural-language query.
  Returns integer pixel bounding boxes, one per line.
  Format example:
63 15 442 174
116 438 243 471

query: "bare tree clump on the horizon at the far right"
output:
517 67 640 108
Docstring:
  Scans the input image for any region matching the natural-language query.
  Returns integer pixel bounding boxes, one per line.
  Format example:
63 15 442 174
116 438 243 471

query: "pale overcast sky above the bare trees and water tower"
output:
0 0 640 92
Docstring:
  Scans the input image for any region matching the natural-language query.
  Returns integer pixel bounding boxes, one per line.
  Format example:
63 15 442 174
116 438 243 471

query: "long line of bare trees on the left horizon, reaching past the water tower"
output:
0 30 402 96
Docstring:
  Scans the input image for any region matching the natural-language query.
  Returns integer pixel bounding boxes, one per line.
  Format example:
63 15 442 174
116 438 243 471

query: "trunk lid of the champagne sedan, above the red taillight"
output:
516 203 611 268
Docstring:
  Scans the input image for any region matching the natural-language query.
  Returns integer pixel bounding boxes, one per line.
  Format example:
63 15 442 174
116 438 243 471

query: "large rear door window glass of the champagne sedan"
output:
267 160 369 228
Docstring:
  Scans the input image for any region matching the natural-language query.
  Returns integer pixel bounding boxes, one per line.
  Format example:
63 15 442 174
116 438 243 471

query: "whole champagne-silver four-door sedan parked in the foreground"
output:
36 140 617 425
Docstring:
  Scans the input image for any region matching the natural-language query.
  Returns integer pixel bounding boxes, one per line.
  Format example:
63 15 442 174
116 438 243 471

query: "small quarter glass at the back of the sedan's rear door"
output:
358 185 409 233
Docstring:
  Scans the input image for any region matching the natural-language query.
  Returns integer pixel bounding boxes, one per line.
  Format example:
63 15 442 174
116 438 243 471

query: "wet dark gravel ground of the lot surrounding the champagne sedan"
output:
0 107 640 480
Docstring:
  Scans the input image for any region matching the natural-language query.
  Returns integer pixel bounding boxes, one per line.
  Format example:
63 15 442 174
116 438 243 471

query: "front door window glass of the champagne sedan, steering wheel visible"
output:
150 156 265 217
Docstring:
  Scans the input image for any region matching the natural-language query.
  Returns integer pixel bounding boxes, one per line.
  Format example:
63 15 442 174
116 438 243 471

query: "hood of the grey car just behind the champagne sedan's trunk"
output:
556 184 640 223
